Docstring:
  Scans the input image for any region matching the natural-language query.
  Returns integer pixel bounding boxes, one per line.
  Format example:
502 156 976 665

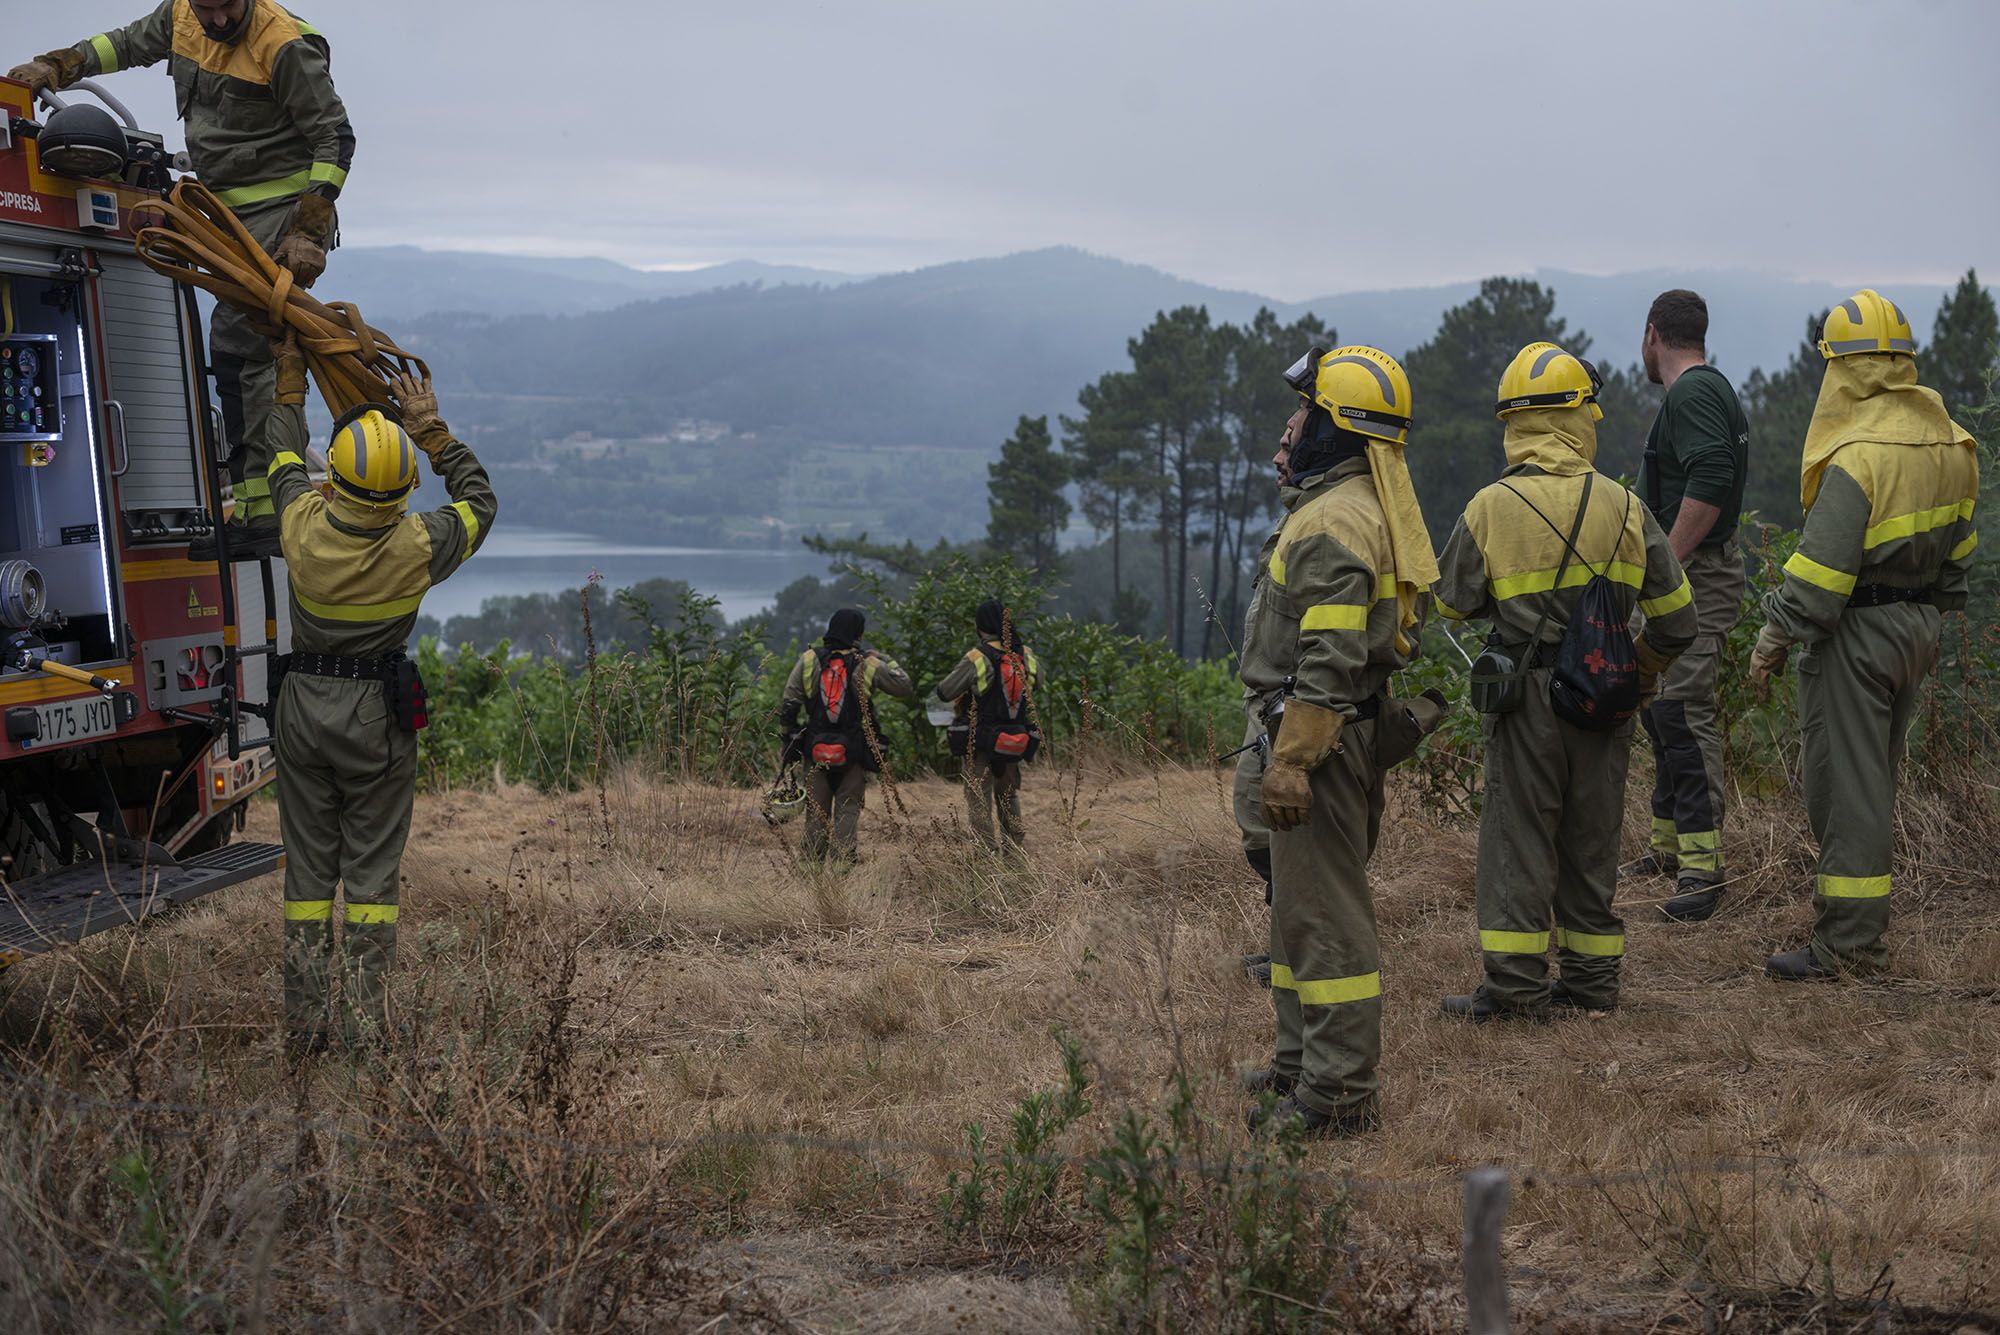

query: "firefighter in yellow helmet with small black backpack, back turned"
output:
1436 344 1698 1021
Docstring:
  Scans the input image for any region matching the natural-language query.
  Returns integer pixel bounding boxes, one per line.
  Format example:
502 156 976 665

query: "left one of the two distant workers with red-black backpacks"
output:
780 608 916 863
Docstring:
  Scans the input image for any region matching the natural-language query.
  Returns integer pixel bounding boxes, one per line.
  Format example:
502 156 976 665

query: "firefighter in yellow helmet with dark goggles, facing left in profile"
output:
1242 346 1436 1135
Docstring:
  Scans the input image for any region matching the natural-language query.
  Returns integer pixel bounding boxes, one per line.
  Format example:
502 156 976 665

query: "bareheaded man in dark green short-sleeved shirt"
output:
1626 290 1750 921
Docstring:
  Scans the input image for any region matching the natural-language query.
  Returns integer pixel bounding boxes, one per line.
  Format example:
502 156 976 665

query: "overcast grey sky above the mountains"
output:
19 0 2000 300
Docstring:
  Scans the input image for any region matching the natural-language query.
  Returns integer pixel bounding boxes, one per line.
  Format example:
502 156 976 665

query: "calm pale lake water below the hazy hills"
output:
424 526 826 624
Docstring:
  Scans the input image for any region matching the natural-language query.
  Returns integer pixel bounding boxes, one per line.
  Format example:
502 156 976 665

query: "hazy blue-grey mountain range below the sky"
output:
356 248 1942 452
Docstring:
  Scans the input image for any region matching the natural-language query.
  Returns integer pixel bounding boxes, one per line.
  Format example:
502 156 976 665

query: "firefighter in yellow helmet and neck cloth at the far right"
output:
1750 290 1980 981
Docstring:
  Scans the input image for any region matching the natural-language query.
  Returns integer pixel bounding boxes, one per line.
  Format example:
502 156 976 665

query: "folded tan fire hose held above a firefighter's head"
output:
134 180 430 418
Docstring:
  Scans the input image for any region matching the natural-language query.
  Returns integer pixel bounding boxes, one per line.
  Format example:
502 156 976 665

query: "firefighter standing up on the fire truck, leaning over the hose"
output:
12 0 354 560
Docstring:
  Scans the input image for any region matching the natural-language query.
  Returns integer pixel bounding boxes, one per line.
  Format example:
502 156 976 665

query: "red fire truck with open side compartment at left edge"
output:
0 78 284 967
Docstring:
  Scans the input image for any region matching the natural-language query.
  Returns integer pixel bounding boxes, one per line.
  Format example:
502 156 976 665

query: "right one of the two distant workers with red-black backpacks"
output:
936 598 1042 853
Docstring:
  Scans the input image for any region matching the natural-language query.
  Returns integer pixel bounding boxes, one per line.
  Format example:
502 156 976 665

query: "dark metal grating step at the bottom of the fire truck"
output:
0 843 284 967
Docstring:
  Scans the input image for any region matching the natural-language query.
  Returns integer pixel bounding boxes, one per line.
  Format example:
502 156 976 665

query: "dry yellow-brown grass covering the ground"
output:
0 747 2000 1329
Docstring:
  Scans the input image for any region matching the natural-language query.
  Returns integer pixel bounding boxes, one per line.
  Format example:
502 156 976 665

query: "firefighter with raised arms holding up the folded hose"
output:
270 335 498 1051
